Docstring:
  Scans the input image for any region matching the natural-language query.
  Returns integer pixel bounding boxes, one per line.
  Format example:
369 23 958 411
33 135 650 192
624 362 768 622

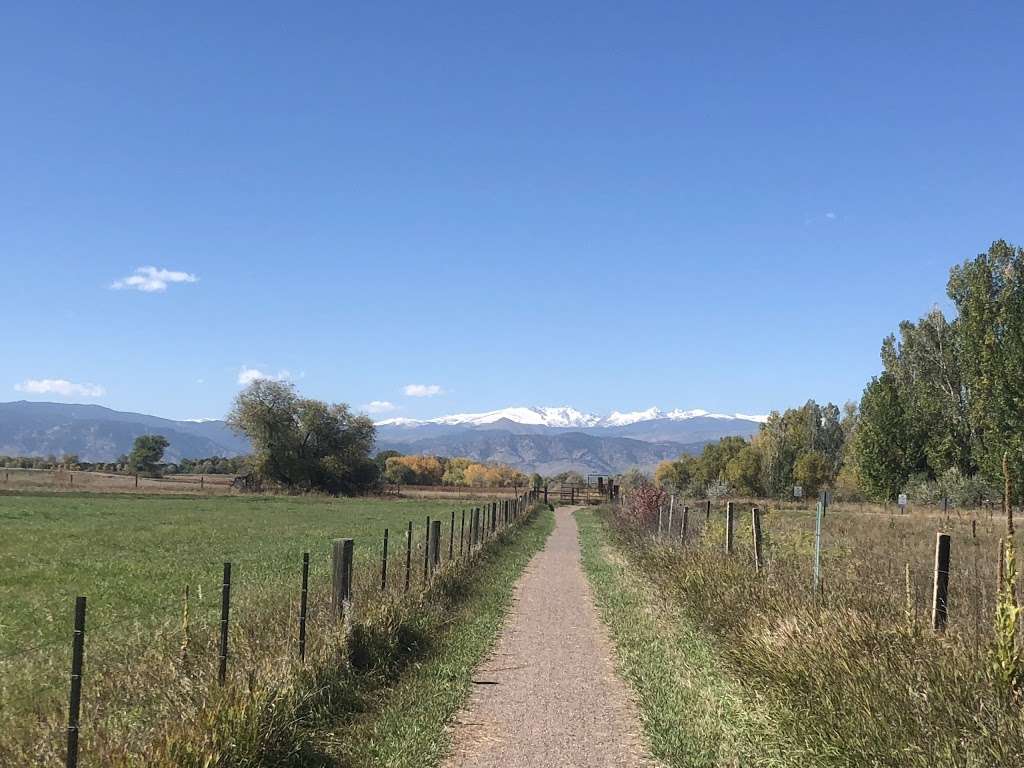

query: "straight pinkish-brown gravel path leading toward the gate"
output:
444 507 655 768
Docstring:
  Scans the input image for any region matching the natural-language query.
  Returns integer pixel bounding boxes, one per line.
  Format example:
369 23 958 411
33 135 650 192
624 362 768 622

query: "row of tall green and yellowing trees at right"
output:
655 241 1024 504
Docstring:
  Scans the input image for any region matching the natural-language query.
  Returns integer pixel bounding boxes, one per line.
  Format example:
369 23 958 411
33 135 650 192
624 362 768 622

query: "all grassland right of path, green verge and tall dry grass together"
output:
580 504 1024 768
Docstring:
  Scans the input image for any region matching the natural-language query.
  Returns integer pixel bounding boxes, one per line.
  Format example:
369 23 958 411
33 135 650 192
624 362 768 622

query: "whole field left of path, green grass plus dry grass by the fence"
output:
0 493 528 764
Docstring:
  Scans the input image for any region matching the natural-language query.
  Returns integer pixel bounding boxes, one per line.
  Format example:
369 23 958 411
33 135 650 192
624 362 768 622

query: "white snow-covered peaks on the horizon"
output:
377 406 767 429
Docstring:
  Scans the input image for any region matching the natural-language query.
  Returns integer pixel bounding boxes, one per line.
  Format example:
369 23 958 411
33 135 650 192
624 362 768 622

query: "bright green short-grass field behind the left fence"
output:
0 494 477 655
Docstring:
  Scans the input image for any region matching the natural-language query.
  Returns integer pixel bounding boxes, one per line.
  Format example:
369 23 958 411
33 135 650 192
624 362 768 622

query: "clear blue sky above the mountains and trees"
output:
0 0 1024 418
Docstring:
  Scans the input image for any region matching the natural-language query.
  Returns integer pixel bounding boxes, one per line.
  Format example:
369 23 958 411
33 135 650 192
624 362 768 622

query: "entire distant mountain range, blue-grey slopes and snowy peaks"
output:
0 400 764 474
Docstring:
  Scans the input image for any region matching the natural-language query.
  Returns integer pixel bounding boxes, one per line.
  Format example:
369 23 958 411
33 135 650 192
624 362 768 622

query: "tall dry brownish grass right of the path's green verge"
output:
603 507 1024 768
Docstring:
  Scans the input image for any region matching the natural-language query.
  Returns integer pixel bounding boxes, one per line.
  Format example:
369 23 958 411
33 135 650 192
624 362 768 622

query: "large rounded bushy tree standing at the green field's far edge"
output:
227 379 378 494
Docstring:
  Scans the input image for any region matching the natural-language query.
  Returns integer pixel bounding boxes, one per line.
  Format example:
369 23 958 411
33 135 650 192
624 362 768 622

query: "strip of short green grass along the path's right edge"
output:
577 508 826 768
